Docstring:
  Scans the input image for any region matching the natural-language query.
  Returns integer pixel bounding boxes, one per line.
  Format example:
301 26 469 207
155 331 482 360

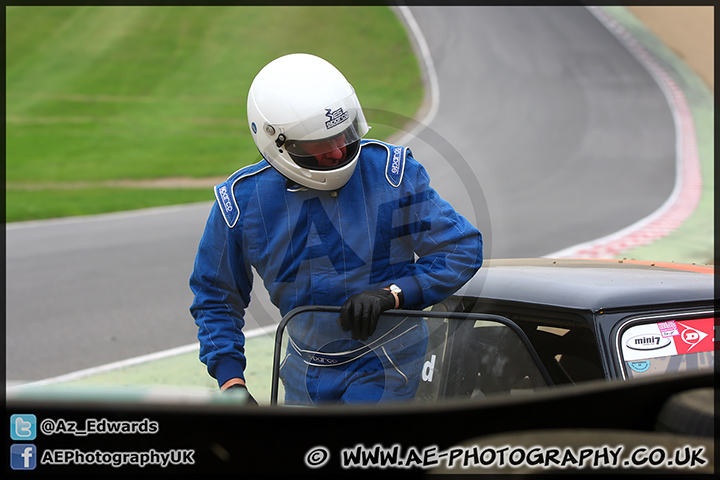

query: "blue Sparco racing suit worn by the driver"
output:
190 140 482 403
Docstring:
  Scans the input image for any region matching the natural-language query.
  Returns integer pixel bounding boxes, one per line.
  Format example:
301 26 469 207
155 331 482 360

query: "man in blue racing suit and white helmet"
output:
190 54 482 404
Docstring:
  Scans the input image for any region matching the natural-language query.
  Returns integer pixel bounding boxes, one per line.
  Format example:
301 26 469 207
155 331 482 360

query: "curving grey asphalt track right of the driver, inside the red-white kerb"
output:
400 7 675 258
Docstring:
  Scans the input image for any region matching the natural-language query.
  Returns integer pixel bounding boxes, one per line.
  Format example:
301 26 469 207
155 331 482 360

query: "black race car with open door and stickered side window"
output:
271 258 715 403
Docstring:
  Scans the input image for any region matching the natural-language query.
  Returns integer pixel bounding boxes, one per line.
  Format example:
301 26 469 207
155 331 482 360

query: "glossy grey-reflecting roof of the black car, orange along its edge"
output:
457 258 715 311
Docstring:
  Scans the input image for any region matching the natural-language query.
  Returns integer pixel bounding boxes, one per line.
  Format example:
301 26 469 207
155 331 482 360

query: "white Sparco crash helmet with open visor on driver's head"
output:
247 53 370 190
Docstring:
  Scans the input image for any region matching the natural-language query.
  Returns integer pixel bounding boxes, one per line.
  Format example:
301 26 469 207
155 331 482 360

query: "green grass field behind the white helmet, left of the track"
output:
5 6 423 221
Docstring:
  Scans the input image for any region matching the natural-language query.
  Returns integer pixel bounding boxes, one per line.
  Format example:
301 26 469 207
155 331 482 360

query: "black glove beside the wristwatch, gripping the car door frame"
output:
338 290 395 340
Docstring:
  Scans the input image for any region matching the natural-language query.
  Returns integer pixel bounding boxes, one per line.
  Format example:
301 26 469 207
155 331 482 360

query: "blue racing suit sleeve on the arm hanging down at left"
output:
190 202 252 385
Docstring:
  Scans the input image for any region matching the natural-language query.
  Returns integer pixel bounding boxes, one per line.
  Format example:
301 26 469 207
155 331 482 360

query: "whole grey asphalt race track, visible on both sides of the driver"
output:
6 7 675 383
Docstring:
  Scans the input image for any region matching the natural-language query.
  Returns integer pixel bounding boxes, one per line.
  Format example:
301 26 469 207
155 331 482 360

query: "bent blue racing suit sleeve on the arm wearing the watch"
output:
394 156 483 309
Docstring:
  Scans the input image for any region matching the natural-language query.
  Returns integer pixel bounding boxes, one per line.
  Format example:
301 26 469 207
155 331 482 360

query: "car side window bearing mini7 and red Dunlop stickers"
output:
618 316 715 378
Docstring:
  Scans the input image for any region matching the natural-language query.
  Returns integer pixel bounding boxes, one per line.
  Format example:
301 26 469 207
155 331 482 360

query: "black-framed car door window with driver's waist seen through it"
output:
271 307 552 406
